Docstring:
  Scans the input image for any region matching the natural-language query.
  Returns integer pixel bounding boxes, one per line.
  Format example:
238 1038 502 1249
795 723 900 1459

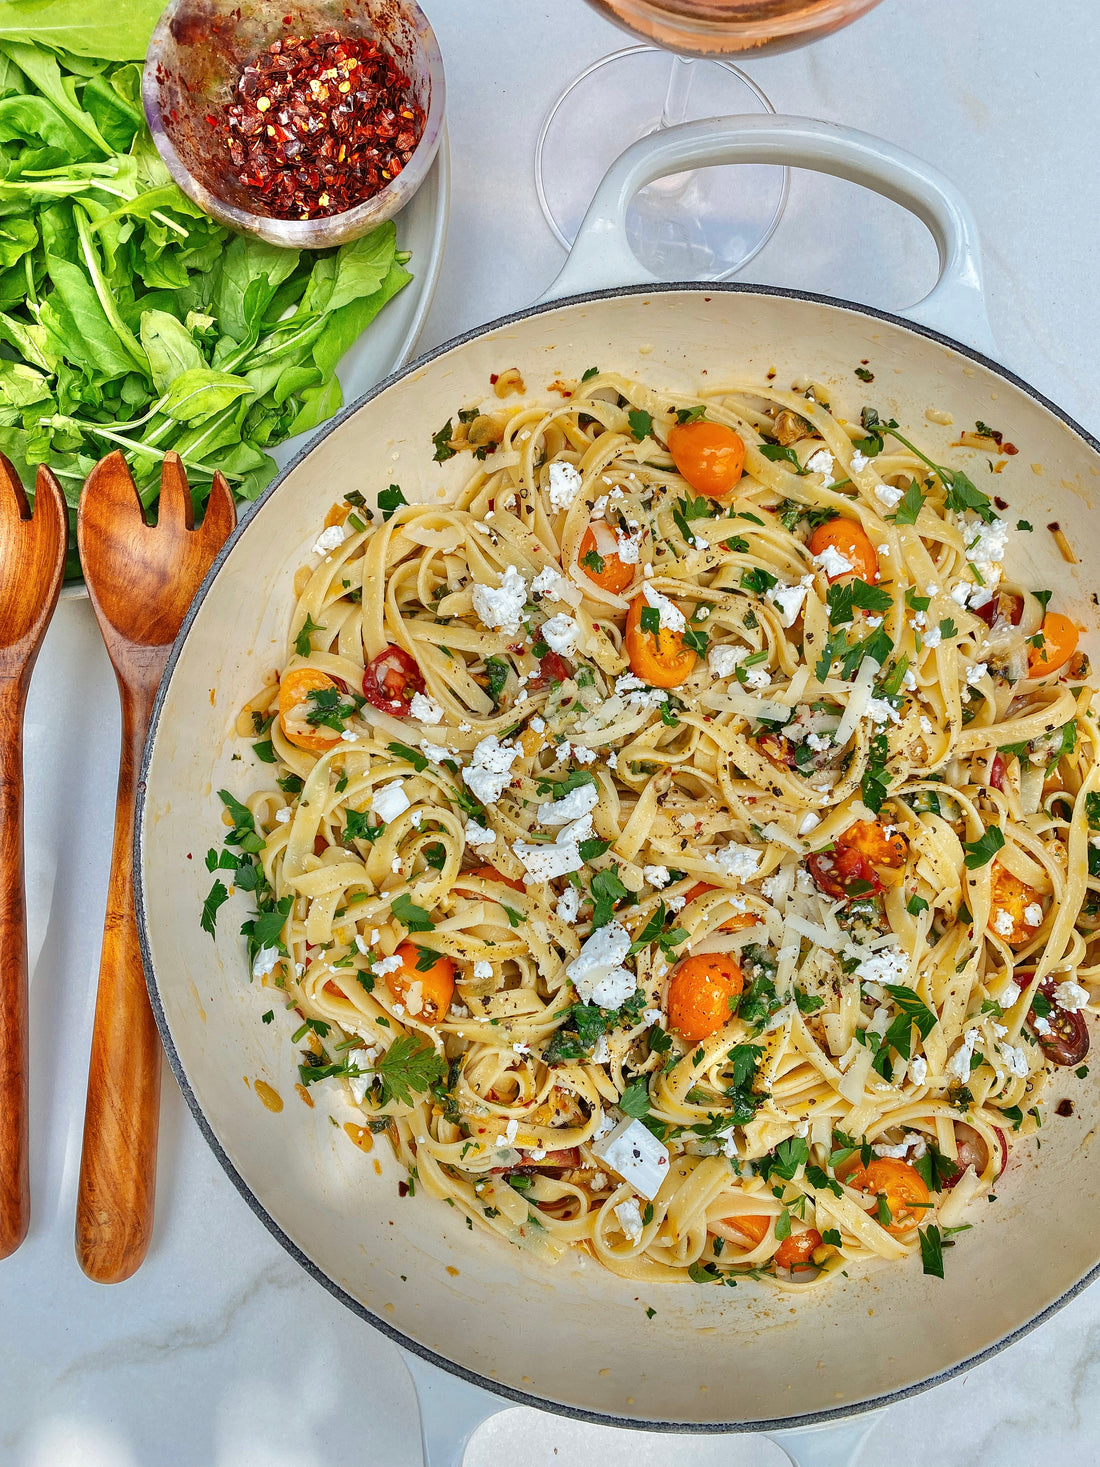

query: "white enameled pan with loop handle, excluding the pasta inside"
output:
135 116 1100 1464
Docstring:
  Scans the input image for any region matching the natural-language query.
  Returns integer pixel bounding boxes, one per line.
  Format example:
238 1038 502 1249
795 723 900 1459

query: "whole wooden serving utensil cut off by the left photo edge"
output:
0 453 69 1259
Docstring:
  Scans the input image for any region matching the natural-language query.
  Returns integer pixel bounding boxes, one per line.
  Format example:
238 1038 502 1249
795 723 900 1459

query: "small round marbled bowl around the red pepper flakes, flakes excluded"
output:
141 0 446 249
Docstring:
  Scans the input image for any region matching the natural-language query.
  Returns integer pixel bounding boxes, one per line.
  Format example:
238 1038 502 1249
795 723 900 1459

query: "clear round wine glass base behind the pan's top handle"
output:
535 45 789 280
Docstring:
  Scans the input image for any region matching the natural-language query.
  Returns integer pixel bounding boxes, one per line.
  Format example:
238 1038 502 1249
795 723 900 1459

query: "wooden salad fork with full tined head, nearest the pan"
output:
76 453 236 1284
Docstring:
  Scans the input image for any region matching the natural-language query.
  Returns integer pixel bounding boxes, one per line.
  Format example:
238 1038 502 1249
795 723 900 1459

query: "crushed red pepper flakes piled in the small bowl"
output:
207 28 424 219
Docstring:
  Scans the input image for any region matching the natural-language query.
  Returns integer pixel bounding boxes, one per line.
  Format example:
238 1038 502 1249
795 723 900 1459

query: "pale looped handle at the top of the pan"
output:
538 114 999 359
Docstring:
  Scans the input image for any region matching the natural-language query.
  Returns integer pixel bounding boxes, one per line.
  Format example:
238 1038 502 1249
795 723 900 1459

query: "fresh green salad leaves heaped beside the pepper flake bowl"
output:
0 34 411 575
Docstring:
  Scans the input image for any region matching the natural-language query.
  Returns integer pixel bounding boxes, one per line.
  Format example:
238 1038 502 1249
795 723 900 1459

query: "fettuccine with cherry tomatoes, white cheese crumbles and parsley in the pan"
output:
211 373 1100 1292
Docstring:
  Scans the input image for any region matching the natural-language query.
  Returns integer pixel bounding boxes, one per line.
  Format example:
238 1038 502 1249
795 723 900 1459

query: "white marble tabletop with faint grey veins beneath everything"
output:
0 0 1100 1467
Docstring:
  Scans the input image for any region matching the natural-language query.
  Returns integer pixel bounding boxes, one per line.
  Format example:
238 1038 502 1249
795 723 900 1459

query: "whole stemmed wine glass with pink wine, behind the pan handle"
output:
535 0 879 280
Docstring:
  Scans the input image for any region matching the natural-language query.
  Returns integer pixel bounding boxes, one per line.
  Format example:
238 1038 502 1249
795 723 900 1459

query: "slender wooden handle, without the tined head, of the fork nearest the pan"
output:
76 668 167 1284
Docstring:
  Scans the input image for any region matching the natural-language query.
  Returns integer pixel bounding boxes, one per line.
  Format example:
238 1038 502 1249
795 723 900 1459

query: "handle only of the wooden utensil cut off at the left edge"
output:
0 676 31 1259
